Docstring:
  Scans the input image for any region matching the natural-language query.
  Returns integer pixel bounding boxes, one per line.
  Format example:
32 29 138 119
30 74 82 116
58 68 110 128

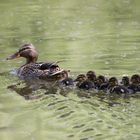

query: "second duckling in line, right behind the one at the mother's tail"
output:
75 74 95 90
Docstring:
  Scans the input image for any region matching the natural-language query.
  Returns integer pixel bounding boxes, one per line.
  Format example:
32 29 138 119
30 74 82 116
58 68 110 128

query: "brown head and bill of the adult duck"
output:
7 44 38 64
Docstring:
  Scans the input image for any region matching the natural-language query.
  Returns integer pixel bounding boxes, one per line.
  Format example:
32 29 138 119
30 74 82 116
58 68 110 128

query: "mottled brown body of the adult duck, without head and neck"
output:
18 63 64 81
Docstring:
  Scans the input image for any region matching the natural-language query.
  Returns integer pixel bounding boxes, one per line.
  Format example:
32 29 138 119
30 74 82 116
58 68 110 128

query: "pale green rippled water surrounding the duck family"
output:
0 0 140 140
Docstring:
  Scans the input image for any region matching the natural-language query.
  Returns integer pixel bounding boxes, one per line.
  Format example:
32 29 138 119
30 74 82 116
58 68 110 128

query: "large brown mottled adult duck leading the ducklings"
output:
7 44 67 80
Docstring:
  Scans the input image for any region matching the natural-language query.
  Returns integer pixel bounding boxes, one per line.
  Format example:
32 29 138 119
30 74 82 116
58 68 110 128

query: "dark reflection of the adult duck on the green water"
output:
7 80 58 100
